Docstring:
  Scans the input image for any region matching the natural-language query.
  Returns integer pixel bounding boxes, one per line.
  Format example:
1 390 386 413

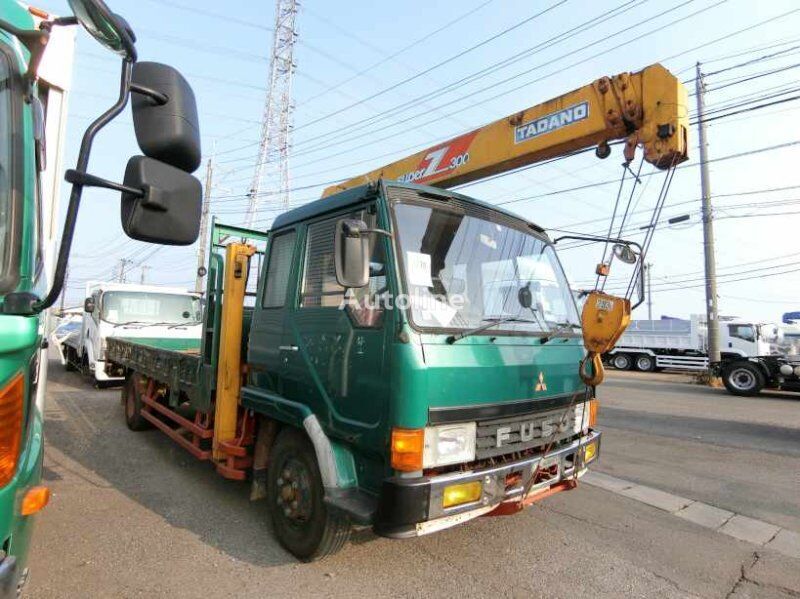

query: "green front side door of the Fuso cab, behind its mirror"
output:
288 205 391 438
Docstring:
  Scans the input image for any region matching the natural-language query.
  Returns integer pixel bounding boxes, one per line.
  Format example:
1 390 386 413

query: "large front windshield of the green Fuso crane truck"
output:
395 204 579 334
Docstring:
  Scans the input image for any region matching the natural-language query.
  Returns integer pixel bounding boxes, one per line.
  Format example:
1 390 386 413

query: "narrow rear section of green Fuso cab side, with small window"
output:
247 229 299 397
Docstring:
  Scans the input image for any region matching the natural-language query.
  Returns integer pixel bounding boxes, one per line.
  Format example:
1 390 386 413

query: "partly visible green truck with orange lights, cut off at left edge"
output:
0 2 74 597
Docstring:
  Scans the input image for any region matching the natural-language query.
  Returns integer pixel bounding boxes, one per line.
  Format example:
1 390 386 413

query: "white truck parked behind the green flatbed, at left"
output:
60 282 202 385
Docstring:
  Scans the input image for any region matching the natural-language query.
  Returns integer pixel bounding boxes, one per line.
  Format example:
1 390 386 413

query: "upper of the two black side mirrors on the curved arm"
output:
131 62 201 173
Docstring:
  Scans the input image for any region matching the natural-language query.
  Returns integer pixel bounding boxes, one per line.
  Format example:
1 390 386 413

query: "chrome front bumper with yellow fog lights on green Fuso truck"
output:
373 430 600 538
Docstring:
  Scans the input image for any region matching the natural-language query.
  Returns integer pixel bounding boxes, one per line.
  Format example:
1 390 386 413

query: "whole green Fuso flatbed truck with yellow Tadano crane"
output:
106 65 688 560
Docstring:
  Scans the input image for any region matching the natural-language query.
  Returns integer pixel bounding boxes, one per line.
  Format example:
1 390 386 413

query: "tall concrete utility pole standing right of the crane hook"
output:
695 62 721 376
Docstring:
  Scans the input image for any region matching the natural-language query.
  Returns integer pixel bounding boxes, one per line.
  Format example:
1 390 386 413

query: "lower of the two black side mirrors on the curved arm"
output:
120 156 203 245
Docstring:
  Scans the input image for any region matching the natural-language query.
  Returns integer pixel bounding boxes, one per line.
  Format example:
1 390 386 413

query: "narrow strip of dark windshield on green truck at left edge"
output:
0 52 14 291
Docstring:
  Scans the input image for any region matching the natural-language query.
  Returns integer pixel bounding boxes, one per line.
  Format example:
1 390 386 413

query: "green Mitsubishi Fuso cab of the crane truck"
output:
241 182 600 555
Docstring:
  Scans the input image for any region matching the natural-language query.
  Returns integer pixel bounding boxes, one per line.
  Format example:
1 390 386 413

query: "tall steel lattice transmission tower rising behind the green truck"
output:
245 0 298 227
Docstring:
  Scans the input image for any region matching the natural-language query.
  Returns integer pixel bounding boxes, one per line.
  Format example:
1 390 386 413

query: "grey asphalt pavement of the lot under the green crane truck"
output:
21 362 800 598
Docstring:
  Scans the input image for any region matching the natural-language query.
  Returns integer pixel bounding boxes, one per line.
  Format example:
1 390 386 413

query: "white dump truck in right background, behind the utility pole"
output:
603 314 779 372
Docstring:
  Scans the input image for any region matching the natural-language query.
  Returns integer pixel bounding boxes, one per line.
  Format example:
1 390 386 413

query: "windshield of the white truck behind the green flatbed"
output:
100 291 201 324
